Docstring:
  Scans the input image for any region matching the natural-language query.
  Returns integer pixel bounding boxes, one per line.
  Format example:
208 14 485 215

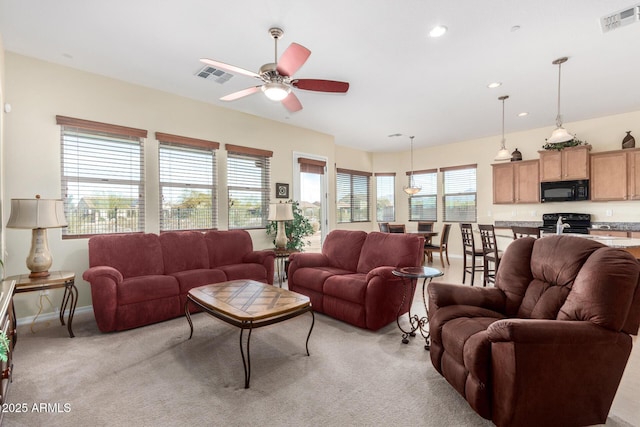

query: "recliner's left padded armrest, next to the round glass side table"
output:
427 282 505 313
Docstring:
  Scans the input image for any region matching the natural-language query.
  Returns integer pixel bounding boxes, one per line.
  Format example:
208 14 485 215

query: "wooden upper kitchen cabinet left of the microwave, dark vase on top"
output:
492 160 540 204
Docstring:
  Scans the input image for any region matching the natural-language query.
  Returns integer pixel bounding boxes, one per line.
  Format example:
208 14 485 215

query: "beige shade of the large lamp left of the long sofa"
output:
7 196 68 230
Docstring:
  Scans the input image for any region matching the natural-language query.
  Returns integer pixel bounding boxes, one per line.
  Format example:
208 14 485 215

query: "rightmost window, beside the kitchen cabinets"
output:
440 165 477 222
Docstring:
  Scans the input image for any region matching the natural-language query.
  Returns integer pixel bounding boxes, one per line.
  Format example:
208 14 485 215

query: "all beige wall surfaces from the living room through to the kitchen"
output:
0 46 640 318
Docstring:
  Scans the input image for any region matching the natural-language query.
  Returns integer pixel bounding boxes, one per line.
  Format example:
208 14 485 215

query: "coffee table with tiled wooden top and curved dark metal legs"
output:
184 280 315 388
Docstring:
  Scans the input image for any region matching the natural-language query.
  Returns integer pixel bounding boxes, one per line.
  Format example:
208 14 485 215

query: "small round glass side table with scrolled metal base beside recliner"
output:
392 267 444 350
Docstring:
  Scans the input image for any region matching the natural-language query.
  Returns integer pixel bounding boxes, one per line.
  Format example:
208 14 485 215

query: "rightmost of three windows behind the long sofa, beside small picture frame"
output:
226 144 273 229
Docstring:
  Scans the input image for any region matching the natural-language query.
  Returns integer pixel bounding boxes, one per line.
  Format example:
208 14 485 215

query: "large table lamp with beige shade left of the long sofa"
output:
7 194 67 278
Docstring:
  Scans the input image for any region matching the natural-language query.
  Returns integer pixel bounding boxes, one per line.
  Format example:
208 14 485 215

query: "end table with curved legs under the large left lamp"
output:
5 271 78 338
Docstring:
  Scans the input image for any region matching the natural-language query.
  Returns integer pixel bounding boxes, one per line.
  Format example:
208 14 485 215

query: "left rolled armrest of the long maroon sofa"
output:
82 266 123 332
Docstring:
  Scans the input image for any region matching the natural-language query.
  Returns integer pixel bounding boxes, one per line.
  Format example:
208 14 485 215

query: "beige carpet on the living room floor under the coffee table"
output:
3 306 628 426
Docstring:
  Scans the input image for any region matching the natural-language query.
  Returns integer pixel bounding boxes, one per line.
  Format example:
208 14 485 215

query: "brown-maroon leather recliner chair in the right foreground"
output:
428 235 640 427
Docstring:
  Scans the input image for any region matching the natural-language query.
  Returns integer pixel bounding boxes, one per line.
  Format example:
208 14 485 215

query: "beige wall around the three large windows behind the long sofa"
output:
2 52 335 318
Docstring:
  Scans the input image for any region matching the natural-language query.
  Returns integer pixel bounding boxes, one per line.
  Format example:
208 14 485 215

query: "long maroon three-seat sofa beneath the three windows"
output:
82 230 275 332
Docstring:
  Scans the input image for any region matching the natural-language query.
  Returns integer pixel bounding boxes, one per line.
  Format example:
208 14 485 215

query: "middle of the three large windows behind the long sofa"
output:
156 132 220 231
